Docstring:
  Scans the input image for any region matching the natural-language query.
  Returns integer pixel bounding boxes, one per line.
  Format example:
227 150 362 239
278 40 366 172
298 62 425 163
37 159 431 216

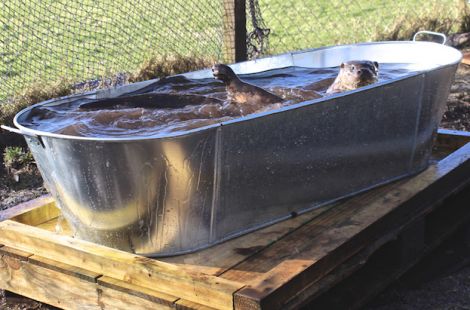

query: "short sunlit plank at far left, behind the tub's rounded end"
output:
0 195 59 226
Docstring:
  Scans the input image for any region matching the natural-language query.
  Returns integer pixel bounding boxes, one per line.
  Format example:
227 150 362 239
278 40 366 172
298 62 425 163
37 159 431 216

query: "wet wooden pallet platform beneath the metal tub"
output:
0 130 470 309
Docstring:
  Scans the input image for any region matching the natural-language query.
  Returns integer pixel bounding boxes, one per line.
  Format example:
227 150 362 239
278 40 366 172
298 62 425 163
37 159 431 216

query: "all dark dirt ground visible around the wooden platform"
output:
0 59 470 310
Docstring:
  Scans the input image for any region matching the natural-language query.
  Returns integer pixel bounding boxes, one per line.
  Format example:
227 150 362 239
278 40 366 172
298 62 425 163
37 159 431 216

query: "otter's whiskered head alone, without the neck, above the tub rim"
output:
339 60 379 89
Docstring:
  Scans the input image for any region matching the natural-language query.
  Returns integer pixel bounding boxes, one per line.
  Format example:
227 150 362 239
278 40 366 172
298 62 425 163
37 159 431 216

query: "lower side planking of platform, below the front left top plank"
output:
0 247 178 309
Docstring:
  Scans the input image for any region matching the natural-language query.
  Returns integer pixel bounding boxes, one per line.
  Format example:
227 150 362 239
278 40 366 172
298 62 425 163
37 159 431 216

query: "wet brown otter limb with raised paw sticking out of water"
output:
212 64 283 110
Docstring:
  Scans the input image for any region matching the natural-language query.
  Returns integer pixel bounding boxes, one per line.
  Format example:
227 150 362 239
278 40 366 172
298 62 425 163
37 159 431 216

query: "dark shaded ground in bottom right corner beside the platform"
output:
365 223 470 310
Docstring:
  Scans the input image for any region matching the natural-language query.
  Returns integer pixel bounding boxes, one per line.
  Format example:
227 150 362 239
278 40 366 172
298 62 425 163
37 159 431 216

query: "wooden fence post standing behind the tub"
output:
223 0 247 63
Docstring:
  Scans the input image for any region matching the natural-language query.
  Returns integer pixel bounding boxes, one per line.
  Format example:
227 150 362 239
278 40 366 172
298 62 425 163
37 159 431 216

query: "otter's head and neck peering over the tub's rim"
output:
326 60 379 94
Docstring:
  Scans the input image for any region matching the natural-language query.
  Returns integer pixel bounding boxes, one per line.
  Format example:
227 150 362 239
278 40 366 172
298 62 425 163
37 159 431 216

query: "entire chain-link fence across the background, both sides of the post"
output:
0 0 466 101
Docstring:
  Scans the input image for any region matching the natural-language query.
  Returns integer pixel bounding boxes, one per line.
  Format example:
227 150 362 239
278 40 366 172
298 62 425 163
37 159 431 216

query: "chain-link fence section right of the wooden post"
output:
247 0 467 56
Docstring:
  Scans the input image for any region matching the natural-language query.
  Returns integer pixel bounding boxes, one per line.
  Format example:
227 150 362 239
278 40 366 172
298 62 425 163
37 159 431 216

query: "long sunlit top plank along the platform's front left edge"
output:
0 220 243 309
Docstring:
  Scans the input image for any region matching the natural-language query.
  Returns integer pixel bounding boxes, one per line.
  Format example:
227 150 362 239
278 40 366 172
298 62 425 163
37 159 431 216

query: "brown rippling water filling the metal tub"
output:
21 64 410 137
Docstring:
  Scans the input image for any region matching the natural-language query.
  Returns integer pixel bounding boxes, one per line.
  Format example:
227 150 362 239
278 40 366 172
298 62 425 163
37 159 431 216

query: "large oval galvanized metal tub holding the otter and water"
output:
9 42 461 256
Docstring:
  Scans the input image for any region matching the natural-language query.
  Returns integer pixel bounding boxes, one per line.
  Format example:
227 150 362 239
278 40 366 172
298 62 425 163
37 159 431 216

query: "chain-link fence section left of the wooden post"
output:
0 0 223 100
